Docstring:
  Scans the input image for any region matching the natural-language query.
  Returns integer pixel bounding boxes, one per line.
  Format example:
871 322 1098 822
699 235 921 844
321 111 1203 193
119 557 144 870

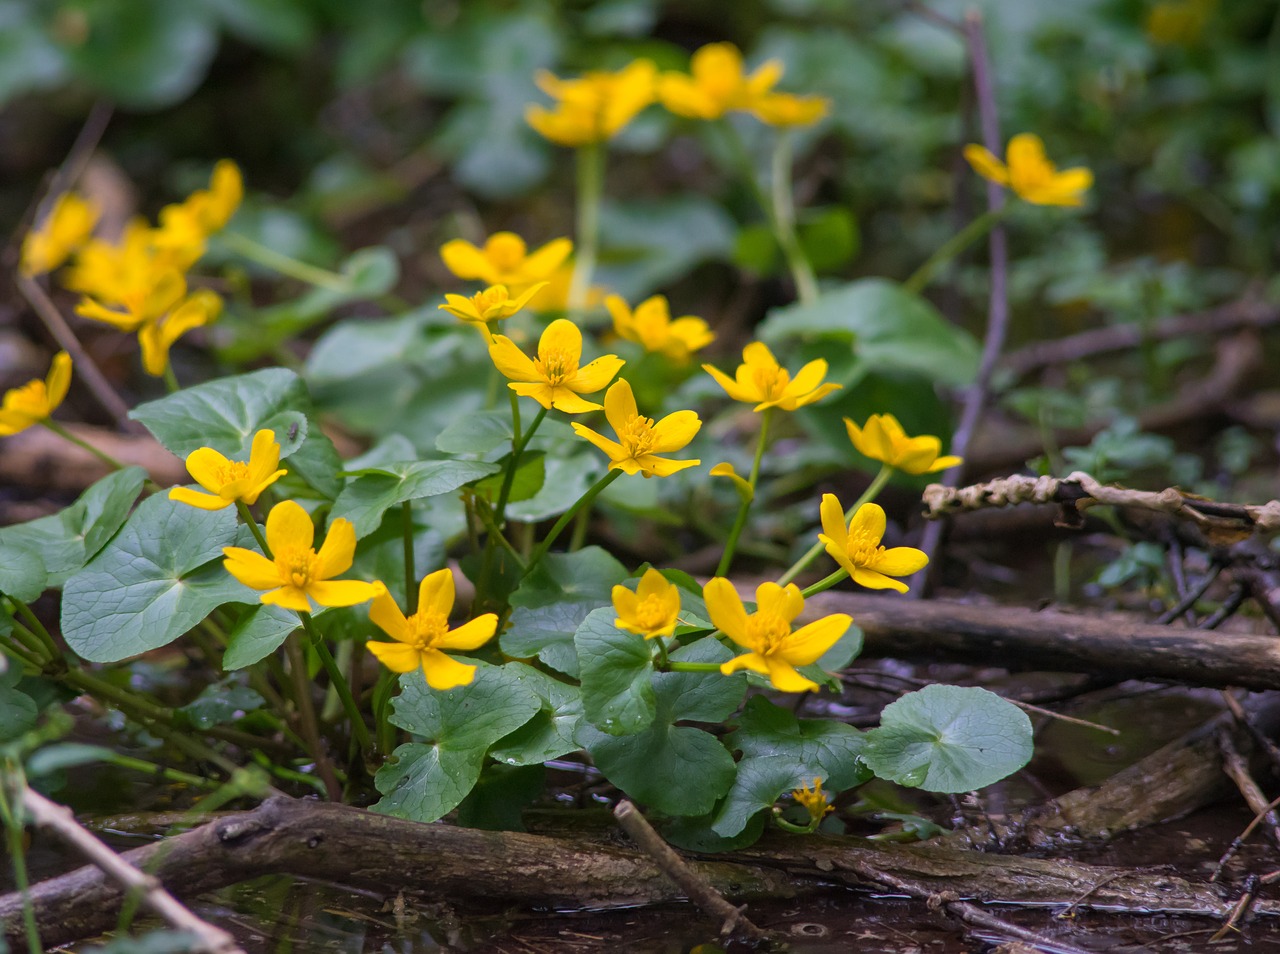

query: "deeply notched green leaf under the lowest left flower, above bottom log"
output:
374 663 541 822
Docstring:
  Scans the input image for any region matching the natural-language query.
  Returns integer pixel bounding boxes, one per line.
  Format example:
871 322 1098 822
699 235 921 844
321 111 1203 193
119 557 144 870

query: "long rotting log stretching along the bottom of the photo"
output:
0 798 1280 946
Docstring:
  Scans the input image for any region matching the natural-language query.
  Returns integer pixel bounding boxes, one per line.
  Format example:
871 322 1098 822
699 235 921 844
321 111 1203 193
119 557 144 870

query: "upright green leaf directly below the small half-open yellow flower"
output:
573 607 658 735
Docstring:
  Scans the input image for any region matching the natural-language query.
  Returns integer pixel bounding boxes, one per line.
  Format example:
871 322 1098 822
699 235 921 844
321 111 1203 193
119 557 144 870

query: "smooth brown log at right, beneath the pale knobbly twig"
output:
805 590 1280 689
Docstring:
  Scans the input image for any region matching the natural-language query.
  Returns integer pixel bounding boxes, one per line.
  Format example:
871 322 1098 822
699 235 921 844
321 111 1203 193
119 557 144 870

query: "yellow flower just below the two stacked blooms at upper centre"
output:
489 318 626 414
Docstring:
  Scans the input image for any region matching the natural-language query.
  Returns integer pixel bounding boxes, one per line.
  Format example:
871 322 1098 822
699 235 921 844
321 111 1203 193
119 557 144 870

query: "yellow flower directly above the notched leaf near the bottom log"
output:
366 567 498 689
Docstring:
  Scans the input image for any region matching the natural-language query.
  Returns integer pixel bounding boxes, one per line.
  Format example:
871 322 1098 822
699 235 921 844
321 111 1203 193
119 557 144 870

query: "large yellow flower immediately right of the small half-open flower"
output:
703 576 852 693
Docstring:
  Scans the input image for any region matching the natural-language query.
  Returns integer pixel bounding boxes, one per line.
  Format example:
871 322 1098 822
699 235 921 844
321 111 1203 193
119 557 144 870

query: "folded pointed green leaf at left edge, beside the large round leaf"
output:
0 467 147 588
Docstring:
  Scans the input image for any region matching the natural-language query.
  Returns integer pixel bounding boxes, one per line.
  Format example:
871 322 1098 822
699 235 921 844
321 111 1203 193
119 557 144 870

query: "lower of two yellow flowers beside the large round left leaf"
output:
223 501 378 612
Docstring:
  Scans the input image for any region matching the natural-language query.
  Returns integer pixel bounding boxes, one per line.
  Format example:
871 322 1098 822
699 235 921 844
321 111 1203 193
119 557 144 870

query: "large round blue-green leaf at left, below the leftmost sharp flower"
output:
63 494 248 662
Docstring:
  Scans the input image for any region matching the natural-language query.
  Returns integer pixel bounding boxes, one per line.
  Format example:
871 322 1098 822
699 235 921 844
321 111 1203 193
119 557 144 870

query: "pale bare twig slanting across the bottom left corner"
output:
22 789 244 954
